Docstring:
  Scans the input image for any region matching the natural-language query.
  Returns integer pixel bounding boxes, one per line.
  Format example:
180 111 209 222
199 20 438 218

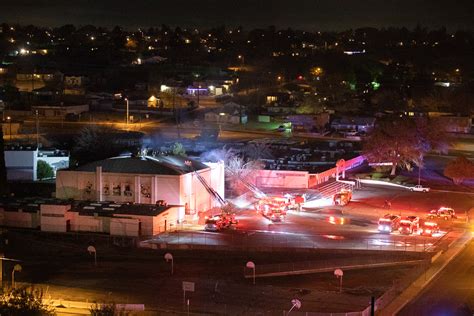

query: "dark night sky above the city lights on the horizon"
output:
0 0 474 30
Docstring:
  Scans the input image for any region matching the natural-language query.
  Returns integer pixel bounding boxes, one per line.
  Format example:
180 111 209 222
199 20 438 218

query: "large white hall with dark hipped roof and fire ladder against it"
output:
56 156 224 215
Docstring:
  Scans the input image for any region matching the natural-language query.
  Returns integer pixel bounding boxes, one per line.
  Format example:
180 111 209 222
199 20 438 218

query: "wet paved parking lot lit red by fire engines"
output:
147 187 474 251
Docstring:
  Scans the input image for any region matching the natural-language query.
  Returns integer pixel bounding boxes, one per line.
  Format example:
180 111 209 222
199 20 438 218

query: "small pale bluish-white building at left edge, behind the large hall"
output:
5 146 69 181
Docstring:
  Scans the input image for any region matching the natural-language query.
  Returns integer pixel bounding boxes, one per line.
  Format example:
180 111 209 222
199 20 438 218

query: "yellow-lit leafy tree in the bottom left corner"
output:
0 287 55 316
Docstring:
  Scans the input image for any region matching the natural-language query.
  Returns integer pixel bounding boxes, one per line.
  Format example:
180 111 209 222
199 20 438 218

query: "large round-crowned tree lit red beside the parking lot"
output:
363 118 447 175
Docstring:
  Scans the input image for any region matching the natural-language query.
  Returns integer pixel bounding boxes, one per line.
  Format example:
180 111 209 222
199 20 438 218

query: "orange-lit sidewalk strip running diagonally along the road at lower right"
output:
377 231 471 315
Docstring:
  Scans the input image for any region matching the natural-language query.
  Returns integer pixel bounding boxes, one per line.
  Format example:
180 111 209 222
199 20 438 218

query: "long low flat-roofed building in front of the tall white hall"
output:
0 199 183 237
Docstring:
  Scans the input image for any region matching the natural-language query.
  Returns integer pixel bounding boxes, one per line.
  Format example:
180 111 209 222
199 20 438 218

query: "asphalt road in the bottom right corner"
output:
398 242 474 316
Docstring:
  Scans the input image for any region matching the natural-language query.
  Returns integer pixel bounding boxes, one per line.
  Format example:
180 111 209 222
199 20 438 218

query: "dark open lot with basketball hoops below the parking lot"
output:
4 232 426 315
